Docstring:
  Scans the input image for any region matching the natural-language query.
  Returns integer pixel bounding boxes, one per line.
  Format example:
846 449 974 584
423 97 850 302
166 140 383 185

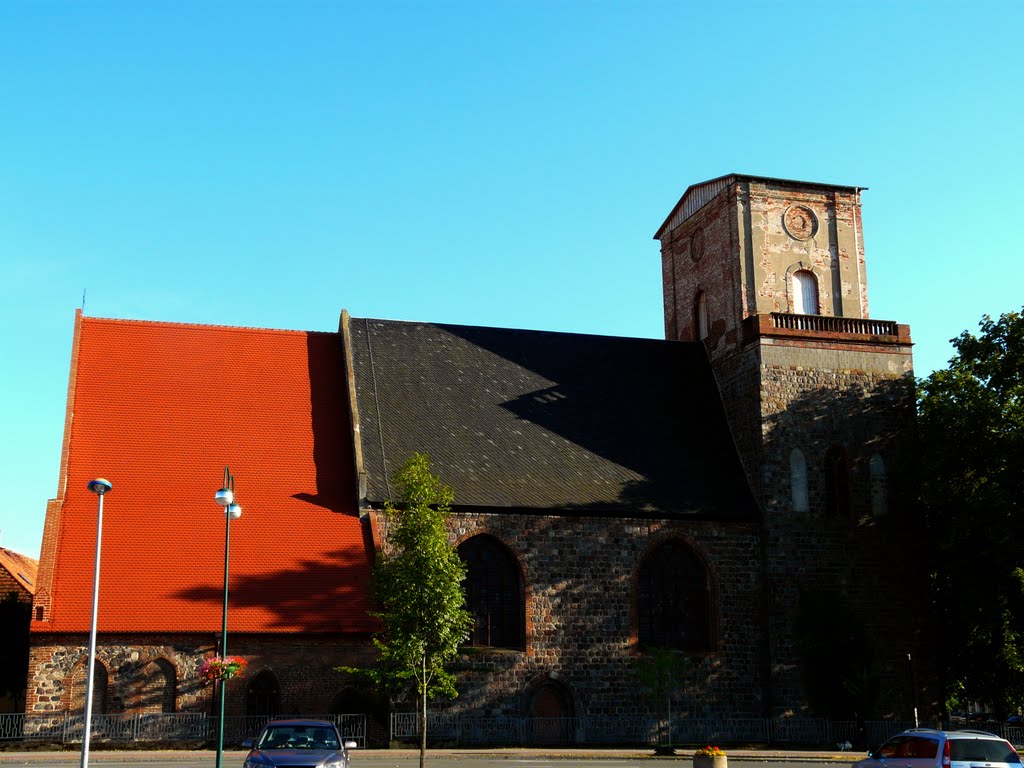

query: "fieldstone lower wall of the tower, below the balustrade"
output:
749 344 929 717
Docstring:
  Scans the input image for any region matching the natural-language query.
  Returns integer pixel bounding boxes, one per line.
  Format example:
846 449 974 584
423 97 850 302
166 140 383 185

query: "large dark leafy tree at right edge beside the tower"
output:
908 312 1024 715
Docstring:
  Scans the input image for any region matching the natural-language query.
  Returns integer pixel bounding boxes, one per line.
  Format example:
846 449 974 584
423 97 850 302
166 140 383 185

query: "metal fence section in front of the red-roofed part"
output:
0 712 367 748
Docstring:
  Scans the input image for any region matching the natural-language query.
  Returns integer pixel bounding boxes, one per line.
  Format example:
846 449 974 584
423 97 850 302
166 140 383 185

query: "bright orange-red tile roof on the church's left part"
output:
33 317 375 633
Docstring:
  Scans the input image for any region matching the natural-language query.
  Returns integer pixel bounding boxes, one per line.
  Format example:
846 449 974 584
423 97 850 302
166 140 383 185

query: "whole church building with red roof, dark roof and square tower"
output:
27 174 929 741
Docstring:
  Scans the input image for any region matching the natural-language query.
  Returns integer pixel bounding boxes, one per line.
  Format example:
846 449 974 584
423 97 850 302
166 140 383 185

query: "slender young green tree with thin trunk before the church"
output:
339 454 473 768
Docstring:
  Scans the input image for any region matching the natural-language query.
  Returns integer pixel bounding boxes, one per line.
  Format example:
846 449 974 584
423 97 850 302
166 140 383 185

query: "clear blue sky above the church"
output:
0 0 1024 556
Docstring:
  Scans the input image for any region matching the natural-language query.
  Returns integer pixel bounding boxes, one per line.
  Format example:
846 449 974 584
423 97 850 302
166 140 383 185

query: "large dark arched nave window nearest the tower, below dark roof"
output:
637 541 712 650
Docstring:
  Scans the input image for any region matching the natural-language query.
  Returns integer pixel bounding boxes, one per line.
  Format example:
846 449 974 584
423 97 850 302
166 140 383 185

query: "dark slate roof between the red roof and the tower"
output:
349 318 758 520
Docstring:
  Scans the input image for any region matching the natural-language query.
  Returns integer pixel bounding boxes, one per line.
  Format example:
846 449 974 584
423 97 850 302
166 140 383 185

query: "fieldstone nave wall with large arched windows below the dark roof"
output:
381 512 763 717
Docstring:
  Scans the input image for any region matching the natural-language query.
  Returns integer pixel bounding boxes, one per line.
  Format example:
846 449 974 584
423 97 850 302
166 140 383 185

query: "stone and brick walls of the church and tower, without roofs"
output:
27 176 929 733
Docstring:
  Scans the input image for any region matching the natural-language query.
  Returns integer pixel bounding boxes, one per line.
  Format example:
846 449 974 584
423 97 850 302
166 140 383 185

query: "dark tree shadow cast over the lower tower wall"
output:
759 373 939 719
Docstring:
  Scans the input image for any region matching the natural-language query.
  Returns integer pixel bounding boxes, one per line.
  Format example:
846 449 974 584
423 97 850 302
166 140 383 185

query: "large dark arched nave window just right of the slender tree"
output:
459 535 526 649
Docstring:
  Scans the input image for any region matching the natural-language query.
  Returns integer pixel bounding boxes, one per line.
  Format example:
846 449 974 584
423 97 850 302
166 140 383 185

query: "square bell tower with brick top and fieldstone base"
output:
654 174 929 715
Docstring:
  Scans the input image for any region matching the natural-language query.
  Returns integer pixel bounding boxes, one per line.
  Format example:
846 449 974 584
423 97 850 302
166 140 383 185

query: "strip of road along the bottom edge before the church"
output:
0 750 861 768
